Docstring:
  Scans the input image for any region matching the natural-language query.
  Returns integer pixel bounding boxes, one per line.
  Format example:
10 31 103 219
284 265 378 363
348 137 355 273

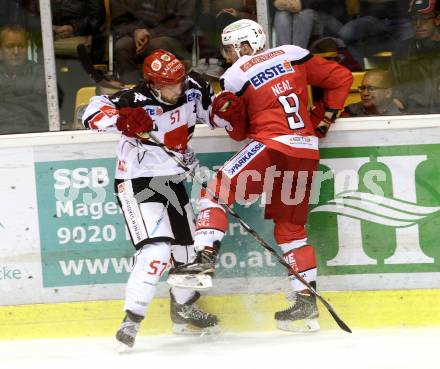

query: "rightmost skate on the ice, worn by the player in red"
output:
275 293 320 332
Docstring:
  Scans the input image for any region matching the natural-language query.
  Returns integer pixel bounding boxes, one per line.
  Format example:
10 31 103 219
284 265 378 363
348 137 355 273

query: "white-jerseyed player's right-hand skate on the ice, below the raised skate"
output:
170 291 220 334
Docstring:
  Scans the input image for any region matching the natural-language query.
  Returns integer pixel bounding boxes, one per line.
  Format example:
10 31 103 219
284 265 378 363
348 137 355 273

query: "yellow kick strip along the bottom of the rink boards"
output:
0 290 440 340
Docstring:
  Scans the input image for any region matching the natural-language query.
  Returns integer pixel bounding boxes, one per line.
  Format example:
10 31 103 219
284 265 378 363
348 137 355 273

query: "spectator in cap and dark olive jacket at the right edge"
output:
390 0 440 114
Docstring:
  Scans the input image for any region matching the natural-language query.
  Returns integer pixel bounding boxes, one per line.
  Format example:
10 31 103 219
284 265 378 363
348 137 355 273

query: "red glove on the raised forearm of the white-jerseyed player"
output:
116 107 153 138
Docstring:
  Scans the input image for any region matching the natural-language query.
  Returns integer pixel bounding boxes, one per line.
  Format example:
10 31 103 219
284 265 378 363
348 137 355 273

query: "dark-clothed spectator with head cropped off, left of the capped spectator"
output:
338 0 412 65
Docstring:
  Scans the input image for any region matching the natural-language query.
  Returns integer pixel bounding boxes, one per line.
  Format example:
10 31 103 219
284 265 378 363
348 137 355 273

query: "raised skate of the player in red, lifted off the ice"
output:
167 241 220 290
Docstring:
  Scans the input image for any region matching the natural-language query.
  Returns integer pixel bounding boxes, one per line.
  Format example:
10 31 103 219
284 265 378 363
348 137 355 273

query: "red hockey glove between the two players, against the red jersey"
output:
211 91 246 127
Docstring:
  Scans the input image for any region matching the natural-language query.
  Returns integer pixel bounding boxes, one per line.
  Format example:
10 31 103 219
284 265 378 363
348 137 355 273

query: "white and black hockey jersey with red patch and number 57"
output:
83 73 214 179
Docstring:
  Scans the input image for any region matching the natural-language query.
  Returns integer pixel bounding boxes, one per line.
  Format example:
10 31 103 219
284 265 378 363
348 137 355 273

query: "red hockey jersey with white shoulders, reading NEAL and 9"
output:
220 45 352 159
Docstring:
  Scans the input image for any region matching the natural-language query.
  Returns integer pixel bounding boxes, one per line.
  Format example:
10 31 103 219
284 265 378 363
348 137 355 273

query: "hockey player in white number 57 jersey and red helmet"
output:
83 50 218 347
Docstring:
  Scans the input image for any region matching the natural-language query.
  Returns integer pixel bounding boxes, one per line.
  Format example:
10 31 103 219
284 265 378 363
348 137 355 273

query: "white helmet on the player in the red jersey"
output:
222 19 266 57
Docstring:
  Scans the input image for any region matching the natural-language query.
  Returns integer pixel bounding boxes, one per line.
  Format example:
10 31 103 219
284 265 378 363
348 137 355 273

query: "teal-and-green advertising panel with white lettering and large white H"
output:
35 145 440 287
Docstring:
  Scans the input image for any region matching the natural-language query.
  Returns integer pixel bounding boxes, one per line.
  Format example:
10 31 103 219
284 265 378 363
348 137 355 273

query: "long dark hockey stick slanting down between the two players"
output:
145 132 352 333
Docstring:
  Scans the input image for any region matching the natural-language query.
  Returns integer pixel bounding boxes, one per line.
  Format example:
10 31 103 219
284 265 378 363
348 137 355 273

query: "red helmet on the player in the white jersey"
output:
143 49 186 85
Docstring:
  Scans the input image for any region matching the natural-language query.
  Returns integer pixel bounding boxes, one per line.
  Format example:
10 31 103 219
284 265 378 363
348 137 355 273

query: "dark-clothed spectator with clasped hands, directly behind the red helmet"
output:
111 0 195 84
